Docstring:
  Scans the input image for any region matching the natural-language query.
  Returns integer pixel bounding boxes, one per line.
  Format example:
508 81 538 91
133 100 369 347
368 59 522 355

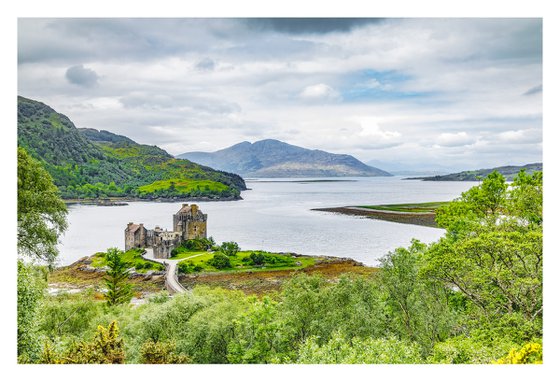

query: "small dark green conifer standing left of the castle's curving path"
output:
105 248 132 305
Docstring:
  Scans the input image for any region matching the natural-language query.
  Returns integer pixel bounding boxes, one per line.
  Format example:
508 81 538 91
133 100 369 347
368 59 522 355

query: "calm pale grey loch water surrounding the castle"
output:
59 177 477 265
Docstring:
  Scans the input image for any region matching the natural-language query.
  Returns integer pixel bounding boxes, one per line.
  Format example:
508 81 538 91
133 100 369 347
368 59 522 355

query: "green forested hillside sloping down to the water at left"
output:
18 97 246 199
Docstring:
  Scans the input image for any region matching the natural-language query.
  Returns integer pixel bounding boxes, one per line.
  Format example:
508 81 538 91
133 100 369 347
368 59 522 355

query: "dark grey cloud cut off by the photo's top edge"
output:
245 17 384 34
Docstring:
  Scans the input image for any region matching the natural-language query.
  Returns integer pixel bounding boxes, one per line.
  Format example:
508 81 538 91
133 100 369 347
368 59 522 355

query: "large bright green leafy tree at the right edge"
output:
423 172 543 321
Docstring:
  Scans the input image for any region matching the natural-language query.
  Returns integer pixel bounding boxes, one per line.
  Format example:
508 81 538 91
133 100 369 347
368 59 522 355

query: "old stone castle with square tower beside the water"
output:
124 204 208 259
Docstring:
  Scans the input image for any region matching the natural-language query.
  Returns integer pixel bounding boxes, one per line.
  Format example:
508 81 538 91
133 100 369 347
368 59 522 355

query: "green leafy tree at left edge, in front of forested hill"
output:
17 147 68 264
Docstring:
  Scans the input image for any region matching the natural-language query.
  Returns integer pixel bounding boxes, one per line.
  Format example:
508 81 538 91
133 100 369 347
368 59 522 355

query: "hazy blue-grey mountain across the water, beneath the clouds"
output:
177 139 391 178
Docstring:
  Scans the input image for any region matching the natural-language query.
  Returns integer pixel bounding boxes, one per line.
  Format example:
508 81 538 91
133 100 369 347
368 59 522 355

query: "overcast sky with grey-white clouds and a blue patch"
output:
18 18 543 170
